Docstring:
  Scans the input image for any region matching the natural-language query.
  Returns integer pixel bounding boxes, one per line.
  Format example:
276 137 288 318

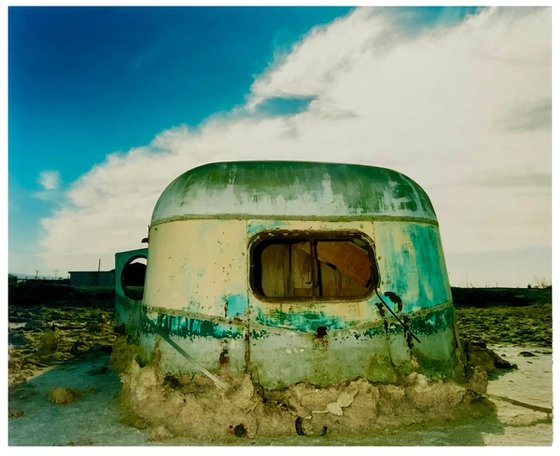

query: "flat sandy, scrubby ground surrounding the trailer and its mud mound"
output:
8 305 552 446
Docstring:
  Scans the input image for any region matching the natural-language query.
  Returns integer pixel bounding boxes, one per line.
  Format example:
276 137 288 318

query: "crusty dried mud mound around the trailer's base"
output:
113 336 494 441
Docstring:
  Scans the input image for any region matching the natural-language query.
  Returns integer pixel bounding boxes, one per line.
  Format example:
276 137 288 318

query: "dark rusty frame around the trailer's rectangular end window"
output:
248 230 380 303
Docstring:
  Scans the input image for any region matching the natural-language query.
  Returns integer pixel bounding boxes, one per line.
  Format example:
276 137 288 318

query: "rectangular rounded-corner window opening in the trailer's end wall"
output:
250 233 378 300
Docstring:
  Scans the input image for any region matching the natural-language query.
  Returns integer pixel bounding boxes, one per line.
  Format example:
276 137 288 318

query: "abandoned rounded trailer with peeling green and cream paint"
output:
116 161 464 389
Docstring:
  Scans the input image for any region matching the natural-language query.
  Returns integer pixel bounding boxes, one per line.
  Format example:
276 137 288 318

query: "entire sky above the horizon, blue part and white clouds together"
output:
4 7 551 285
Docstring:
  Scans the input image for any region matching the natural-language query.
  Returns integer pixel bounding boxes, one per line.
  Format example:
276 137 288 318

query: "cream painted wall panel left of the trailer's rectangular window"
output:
144 220 247 317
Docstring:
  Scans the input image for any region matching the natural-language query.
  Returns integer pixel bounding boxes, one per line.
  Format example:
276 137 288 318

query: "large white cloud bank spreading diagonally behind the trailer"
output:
36 8 551 284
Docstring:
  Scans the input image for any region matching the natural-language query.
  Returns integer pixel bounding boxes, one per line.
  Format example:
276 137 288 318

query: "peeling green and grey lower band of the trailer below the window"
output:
136 303 458 388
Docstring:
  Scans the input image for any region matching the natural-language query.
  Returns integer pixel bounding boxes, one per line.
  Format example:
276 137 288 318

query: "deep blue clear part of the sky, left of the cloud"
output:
8 7 350 274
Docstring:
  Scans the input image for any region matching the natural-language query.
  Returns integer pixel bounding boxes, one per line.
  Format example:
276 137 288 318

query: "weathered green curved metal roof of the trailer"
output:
152 161 437 226
